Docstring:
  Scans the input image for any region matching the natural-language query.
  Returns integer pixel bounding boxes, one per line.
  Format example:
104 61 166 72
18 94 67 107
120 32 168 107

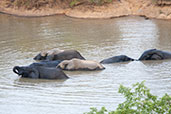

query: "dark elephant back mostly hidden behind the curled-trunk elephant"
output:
30 60 62 67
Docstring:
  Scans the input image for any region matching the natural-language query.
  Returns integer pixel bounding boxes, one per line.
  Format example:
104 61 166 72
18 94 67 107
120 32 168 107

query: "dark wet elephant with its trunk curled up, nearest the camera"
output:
13 65 69 79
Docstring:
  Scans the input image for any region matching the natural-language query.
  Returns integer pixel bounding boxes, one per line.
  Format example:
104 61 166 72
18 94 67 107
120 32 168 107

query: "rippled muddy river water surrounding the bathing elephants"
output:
0 14 171 114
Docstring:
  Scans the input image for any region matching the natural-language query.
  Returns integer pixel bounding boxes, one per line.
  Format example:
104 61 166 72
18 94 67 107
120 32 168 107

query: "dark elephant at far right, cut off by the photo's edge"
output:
138 49 171 61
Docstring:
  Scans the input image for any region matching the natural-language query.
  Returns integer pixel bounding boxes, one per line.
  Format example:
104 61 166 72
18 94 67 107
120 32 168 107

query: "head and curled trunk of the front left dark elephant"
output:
13 66 39 78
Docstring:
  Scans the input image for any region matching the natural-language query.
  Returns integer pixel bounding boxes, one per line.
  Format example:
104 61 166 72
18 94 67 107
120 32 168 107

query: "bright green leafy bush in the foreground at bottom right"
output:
85 81 171 114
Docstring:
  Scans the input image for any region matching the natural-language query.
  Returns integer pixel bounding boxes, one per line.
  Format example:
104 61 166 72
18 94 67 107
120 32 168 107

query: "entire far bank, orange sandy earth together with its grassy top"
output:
0 0 171 19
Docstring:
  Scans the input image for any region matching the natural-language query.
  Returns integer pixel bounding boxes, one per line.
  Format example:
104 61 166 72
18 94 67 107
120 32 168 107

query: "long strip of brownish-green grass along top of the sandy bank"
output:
4 0 114 10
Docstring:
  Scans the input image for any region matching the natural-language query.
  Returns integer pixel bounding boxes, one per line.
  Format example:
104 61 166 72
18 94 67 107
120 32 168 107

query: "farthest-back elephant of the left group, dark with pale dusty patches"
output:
33 50 85 61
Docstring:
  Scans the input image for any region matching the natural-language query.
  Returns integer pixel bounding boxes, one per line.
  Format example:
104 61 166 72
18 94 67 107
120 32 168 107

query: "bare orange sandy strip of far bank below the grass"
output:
0 0 171 19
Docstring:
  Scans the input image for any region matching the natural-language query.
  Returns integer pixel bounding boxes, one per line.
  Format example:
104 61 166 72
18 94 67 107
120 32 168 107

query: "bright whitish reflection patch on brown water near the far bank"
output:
117 18 158 57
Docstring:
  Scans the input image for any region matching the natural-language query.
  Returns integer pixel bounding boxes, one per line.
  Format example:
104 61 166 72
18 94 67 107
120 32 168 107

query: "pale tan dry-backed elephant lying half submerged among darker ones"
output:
57 58 105 71
